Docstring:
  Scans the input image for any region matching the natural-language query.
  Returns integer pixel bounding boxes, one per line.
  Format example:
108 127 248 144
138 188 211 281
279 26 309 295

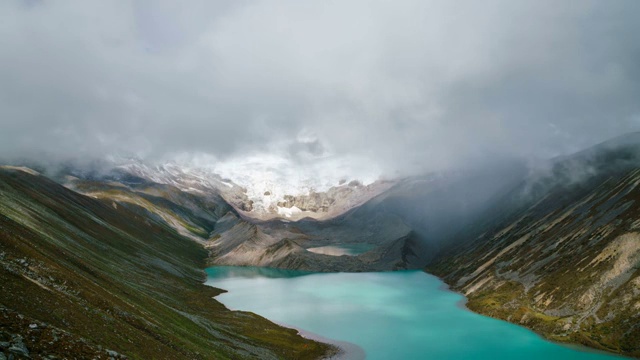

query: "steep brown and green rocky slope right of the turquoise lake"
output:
427 134 640 357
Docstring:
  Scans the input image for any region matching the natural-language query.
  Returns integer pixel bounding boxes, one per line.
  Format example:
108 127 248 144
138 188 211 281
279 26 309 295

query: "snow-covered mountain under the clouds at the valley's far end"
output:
116 161 394 221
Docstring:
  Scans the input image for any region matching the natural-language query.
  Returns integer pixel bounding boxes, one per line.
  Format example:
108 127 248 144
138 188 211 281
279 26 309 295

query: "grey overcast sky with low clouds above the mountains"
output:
0 0 640 184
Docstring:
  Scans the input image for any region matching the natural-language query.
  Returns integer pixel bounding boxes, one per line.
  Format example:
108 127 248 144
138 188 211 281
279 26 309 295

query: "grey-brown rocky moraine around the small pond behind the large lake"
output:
206 213 422 272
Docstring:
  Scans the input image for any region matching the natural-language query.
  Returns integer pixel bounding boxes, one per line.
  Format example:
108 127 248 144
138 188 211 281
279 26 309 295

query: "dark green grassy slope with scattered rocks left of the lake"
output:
0 168 332 359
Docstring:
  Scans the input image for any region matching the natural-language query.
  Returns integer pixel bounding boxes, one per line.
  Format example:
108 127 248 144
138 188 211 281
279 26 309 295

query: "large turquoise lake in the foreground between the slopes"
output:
207 267 621 360
